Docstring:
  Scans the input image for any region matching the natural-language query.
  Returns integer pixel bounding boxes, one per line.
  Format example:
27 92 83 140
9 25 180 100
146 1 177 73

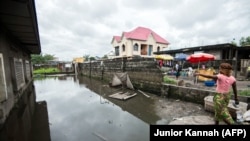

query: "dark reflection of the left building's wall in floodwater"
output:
0 82 36 141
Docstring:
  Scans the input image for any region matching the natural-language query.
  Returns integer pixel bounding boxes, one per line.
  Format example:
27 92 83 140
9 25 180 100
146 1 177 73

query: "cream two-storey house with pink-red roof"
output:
111 27 169 58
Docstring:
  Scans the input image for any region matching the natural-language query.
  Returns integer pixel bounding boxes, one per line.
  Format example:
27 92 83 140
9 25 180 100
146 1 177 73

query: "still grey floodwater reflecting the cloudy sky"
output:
34 76 158 141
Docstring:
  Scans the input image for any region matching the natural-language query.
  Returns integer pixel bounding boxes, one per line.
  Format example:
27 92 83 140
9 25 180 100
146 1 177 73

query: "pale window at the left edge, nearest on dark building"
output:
0 53 8 102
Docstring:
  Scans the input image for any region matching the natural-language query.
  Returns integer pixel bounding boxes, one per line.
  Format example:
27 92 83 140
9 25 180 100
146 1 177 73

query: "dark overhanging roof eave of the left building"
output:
0 0 41 54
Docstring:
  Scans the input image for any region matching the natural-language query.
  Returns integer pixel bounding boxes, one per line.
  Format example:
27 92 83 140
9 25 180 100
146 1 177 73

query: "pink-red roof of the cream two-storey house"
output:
113 27 169 44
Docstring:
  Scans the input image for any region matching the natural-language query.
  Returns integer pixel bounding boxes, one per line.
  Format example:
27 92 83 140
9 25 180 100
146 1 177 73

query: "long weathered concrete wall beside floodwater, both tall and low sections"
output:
78 58 249 104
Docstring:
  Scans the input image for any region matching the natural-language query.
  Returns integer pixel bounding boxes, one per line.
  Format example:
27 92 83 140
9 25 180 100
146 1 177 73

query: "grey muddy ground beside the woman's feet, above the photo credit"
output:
148 95 214 124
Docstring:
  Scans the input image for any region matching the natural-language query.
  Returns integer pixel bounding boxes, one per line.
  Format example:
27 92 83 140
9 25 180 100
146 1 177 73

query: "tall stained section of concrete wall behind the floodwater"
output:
78 58 163 95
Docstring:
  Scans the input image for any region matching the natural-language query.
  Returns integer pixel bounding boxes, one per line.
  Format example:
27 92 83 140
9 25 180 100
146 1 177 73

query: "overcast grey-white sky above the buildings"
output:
35 0 250 61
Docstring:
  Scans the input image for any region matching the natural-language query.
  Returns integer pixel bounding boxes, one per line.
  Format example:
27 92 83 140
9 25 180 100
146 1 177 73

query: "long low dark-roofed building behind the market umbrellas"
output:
154 43 250 75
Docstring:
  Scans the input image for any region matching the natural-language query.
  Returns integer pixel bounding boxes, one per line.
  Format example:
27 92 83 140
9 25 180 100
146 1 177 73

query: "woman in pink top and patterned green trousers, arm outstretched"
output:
195 63 239 125
